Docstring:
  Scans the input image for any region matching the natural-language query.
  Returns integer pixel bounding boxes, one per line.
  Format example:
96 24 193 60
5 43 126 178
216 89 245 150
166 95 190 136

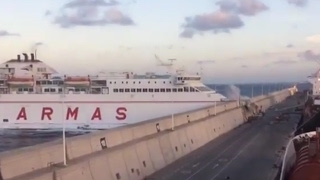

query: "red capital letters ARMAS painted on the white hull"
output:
16 107 127 121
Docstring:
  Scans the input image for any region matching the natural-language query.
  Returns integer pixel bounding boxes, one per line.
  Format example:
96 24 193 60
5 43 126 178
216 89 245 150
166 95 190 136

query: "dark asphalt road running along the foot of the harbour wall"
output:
150 100 299 180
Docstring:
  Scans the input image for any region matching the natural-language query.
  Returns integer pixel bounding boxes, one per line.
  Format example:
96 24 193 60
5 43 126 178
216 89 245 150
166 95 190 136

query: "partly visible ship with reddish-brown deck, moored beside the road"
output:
279 70 320 180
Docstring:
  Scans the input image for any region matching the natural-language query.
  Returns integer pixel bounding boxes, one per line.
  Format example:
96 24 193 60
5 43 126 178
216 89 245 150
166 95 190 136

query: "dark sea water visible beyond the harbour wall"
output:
0 83 312 152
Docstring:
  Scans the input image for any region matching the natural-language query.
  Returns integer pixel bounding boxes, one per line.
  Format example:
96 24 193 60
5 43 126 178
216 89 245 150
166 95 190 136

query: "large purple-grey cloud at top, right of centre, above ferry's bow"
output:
180 0 268 38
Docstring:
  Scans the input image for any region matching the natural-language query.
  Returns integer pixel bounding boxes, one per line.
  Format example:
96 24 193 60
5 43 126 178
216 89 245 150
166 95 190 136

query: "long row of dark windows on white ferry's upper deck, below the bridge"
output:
113 87 197 93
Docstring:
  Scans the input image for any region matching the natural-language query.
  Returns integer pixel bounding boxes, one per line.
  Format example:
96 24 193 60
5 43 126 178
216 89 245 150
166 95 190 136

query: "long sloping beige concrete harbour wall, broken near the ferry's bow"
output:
0 89 295 180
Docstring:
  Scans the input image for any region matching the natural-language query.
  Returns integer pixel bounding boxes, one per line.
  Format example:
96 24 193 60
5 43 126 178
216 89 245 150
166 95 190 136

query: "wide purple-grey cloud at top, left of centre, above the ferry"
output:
48 0 134 28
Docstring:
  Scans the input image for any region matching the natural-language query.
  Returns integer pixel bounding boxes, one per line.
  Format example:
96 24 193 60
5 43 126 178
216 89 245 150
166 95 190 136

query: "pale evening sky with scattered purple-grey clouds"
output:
0 0 320 83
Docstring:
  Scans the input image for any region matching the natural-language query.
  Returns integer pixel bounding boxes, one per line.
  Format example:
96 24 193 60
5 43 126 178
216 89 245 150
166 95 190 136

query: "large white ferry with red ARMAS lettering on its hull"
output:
0 53 226 130
